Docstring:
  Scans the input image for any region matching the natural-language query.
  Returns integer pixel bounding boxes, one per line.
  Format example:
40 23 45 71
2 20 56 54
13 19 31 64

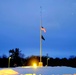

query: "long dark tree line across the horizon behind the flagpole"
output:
0 48 76 68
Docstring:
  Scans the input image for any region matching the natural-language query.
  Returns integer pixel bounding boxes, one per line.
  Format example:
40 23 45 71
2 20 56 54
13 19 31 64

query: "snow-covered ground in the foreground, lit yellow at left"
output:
0 67 76 75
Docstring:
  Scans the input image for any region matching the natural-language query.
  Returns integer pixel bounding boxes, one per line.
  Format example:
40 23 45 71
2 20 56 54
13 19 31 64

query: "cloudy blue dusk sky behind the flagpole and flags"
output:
0 0 76 58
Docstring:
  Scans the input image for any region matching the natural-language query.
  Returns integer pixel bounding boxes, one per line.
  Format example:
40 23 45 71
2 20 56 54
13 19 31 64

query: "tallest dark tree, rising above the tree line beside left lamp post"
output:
9 48 23 66
